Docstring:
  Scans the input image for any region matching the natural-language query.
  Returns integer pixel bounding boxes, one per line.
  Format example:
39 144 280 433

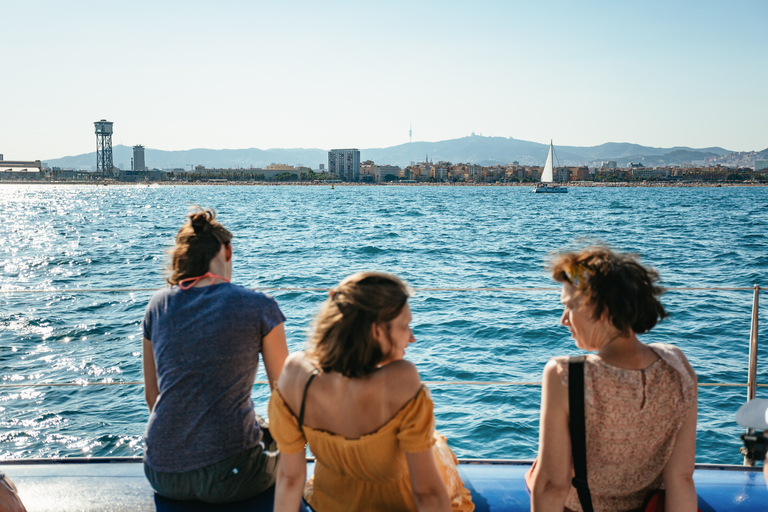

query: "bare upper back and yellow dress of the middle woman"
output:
269 353 473 511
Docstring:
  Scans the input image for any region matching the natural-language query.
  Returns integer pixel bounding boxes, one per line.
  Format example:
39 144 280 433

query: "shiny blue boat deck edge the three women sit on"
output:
0 458 768 512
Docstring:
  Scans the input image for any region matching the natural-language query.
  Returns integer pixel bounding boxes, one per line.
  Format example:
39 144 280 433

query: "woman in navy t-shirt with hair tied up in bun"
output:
142 209 288 503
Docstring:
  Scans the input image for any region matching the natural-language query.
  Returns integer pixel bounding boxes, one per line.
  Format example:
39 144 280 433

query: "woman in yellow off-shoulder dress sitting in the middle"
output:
269 272 474 512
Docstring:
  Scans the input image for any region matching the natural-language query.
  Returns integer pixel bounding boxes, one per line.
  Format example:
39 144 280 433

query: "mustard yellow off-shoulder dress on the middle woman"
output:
269 385 475 512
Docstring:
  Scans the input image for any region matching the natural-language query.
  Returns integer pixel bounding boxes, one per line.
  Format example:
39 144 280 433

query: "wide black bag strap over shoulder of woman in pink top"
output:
568 356 594 512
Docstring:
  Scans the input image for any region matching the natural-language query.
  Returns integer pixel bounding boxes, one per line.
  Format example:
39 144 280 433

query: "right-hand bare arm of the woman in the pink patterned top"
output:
664 359 698 512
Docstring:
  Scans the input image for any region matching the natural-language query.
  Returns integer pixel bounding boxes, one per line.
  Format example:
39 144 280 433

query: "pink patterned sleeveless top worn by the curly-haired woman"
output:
555 344 696 510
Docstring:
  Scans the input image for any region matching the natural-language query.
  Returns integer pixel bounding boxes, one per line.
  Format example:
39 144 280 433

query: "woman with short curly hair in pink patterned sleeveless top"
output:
526 248 697 512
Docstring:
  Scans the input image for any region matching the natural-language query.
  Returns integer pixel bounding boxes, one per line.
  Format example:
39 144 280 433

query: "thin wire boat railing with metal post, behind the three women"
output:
0 284 768 466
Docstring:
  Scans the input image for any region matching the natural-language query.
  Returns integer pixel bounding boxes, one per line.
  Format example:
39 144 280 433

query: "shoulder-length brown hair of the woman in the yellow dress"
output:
307 272 411 378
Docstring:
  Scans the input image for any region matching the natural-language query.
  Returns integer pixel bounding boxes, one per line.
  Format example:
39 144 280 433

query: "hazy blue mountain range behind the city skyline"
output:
44 134 768 170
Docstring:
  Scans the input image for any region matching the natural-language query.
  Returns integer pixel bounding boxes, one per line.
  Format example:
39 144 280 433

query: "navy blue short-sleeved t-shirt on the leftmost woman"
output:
142 283 285 473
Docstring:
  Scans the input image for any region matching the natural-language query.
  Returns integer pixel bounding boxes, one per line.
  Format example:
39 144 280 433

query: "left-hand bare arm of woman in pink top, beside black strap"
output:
529 360 573 512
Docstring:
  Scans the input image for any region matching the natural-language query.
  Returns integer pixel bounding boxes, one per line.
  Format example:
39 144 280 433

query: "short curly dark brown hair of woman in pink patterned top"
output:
552 247 667 334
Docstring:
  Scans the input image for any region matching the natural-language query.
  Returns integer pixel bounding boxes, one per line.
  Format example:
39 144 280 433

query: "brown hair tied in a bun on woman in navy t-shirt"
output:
166 207 232 285
